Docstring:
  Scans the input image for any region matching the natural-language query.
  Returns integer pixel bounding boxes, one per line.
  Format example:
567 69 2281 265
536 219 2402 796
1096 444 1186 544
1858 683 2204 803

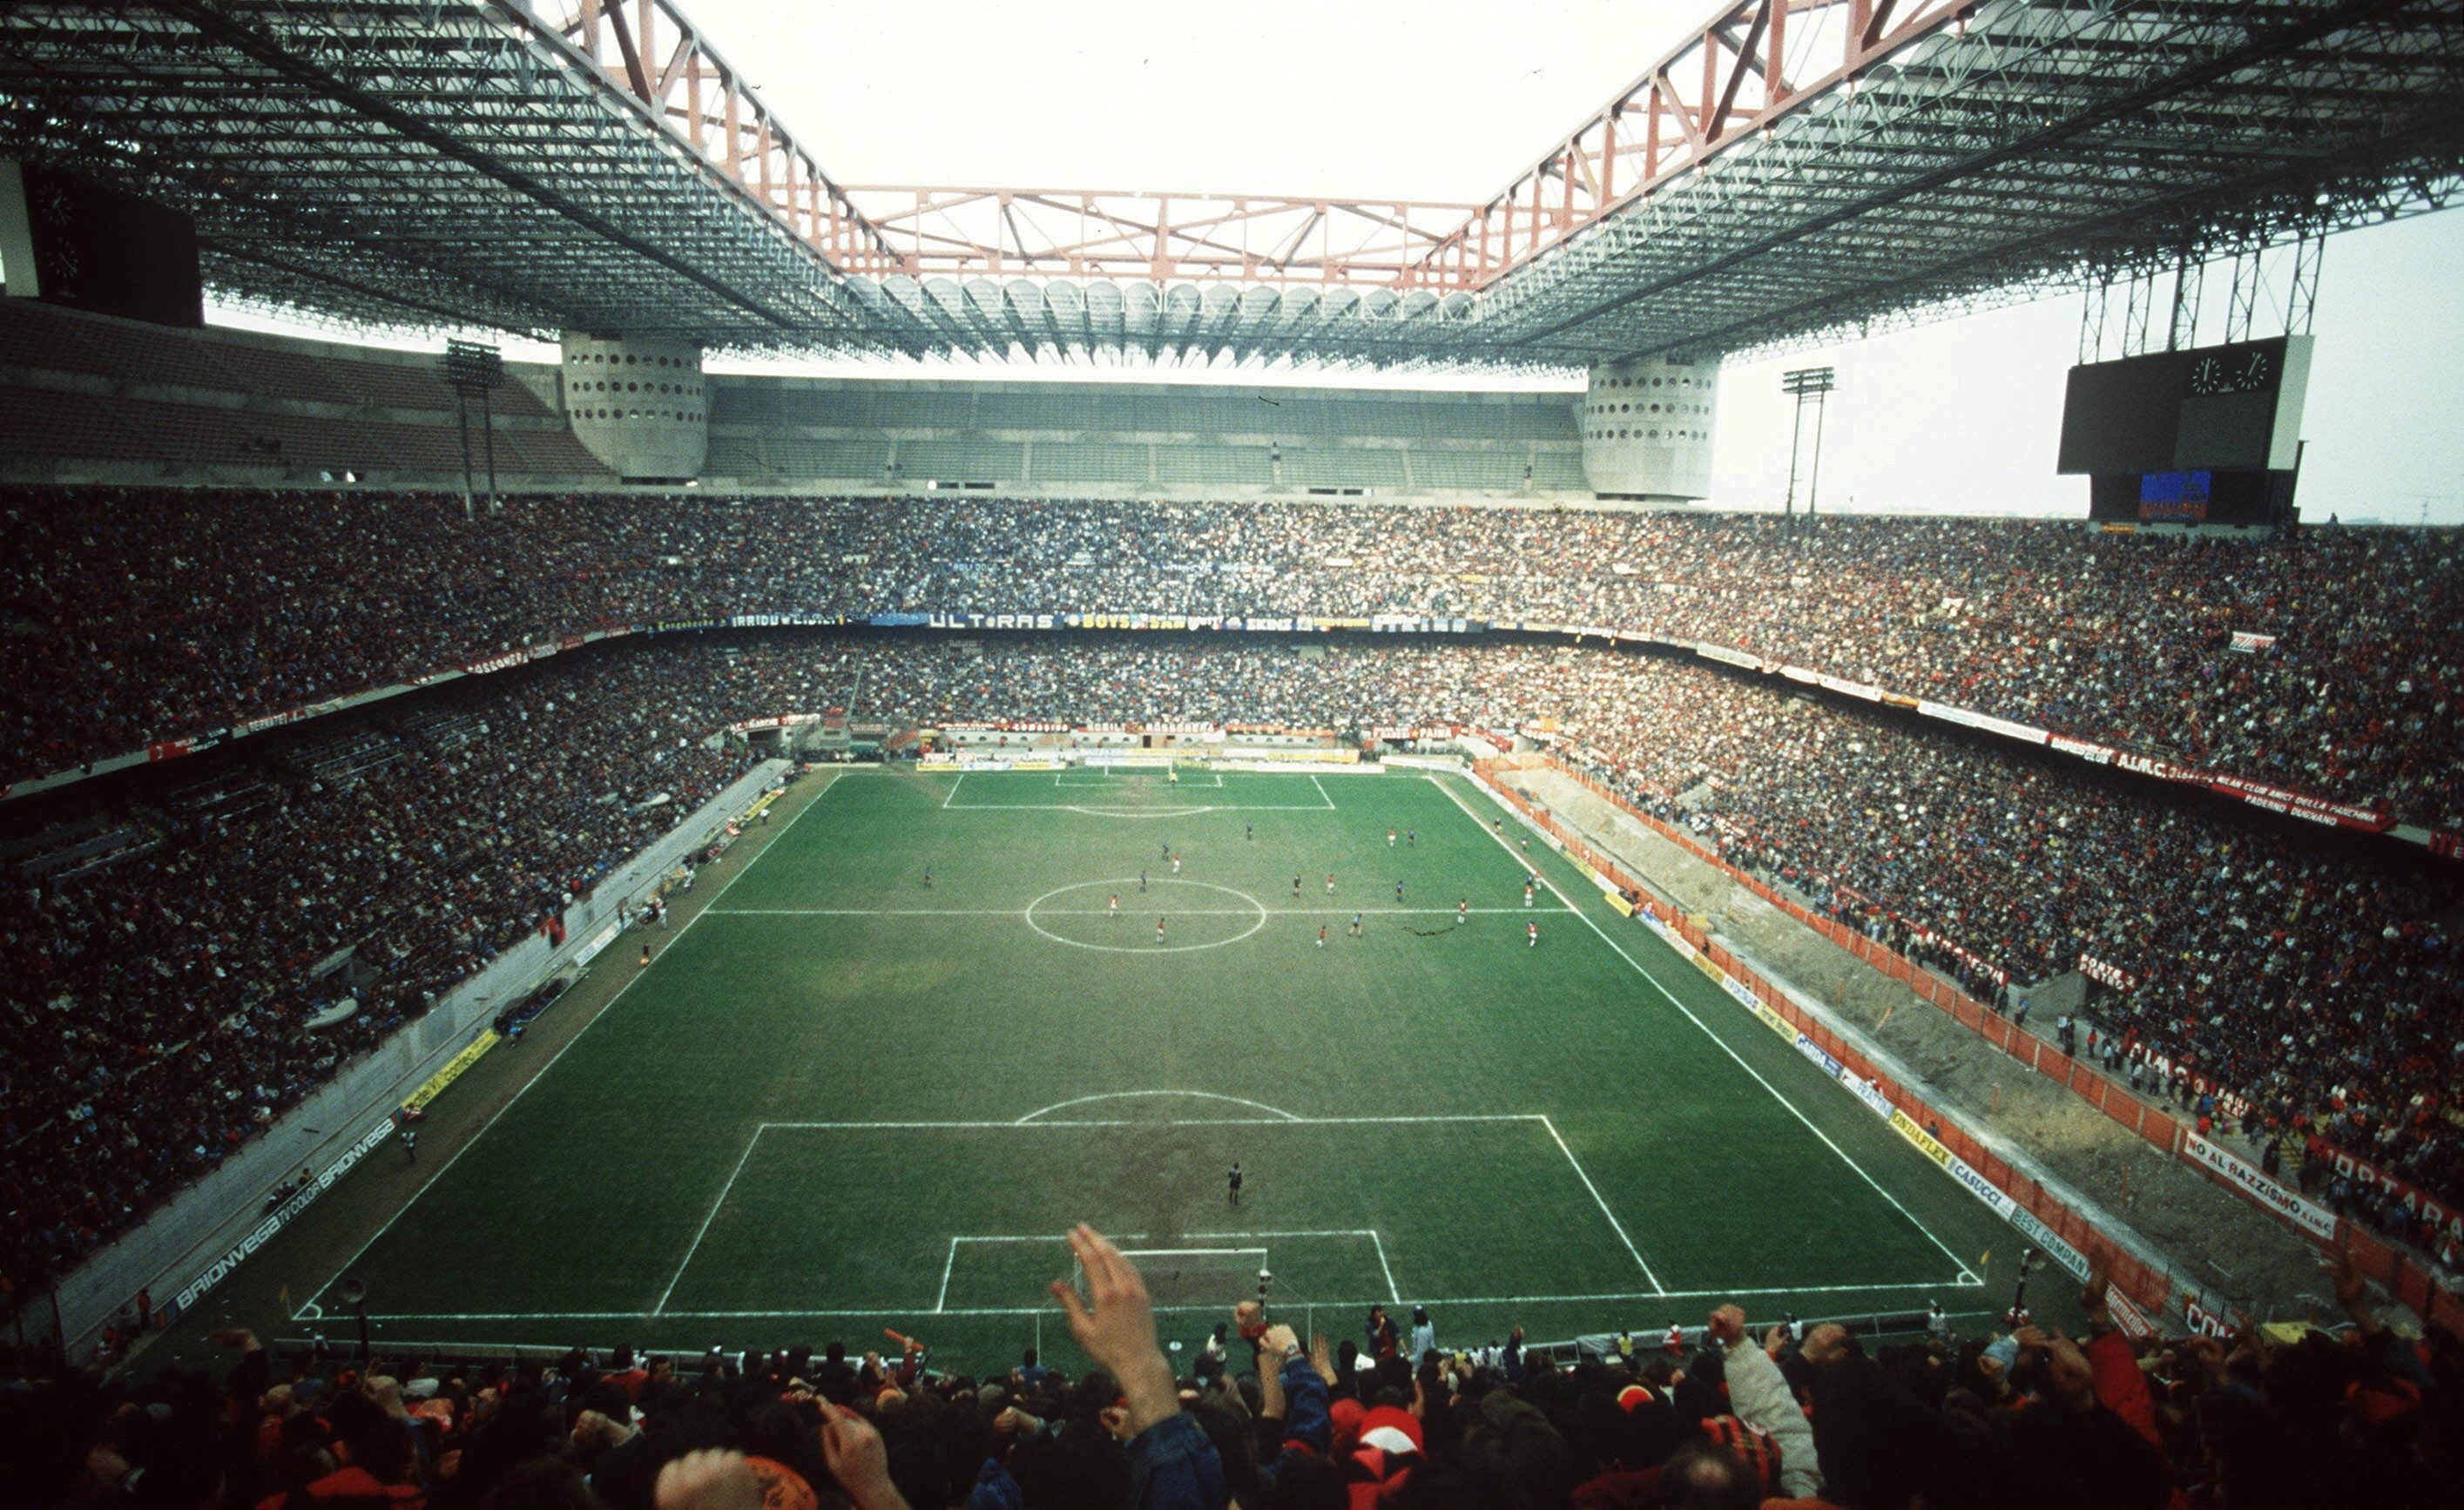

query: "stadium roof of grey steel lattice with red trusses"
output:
0 0 2464 367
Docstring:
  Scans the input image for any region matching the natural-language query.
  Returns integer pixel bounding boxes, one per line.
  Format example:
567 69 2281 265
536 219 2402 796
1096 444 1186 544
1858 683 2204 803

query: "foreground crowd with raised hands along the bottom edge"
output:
0 1227 2464 1510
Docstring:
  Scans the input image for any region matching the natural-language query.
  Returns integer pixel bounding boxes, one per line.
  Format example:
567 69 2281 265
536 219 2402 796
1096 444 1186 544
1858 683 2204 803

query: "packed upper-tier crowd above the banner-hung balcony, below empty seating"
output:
0 490 2464 827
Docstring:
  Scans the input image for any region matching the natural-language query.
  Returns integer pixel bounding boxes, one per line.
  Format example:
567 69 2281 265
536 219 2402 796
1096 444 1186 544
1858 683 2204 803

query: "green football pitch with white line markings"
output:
300 769 2021 1362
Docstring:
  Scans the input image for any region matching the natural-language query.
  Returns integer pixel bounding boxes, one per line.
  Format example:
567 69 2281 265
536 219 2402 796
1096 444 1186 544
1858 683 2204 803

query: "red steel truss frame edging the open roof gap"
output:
562 0 1979 293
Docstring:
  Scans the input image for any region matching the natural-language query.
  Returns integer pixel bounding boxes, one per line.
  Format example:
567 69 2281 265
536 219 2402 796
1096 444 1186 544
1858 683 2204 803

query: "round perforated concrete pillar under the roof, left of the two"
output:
564 330 710 481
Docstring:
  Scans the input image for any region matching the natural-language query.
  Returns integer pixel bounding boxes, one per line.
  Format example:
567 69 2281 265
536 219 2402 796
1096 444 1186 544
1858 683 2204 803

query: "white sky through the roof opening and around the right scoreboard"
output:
212 0 2464 522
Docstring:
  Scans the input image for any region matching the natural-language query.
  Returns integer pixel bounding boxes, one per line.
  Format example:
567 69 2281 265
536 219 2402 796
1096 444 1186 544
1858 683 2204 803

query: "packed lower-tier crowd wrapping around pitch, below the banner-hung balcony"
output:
0 630 2464 1273
